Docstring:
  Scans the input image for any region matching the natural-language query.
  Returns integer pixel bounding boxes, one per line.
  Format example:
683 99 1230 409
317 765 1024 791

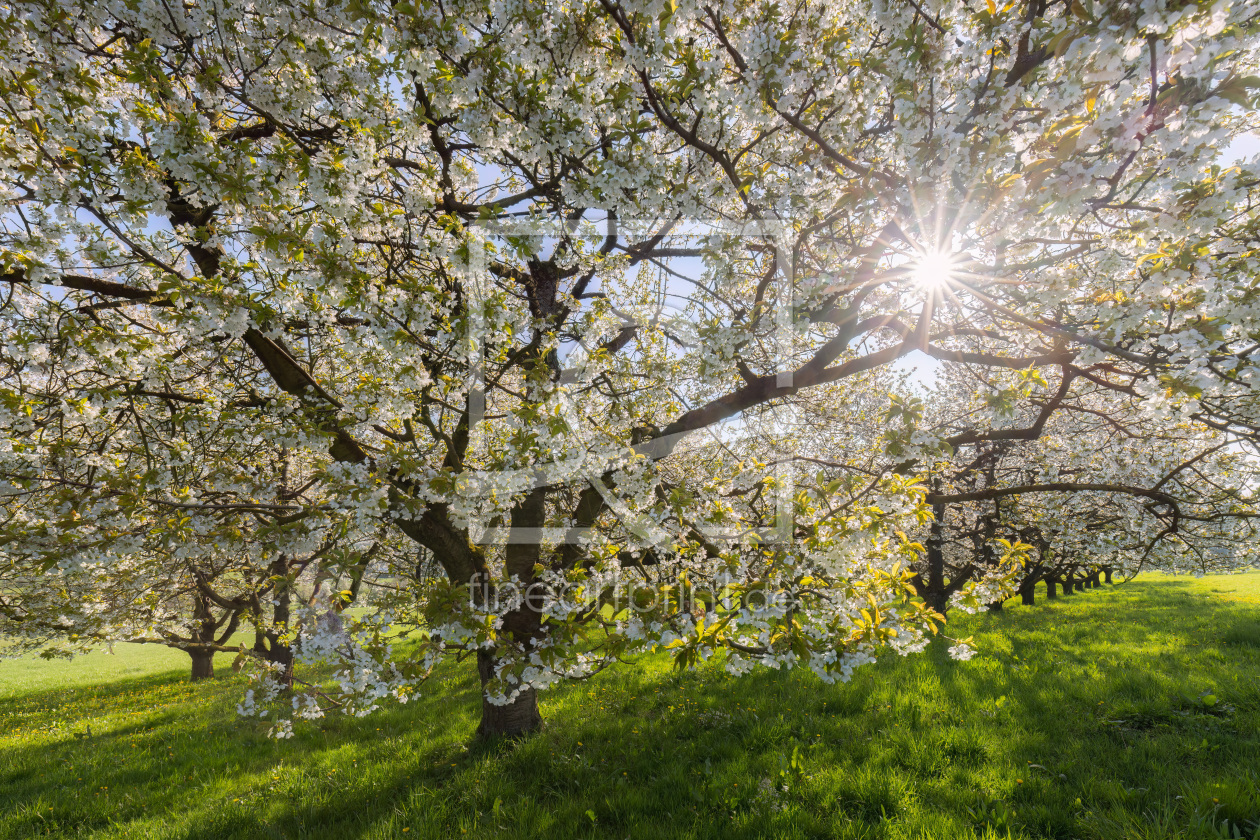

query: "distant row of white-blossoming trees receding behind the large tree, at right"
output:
892 372 1256 612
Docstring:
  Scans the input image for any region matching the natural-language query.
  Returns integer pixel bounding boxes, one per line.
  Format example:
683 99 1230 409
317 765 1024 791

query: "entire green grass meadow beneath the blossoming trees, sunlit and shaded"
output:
0 574 1260 840
